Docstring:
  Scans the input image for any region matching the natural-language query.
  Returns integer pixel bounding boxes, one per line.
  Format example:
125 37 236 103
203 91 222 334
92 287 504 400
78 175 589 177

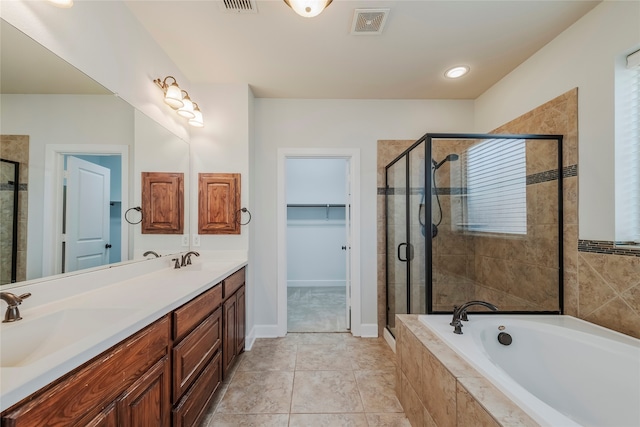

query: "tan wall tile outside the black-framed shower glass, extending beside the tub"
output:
378 88 640 338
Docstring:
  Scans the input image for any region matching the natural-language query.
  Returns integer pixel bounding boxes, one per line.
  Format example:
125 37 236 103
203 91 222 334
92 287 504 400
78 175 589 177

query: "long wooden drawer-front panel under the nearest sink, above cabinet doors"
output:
2 317 169 427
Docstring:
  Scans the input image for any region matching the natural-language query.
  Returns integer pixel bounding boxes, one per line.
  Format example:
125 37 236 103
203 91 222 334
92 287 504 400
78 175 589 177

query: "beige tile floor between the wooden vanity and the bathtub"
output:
201 333 410 427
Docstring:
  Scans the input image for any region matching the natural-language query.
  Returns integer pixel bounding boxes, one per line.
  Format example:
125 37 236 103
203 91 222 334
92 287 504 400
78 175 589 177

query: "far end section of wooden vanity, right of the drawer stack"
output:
222 268 245 378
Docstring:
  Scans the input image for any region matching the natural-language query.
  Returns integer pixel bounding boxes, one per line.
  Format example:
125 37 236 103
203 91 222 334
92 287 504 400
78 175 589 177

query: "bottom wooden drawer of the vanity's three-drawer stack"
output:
173 352 222 427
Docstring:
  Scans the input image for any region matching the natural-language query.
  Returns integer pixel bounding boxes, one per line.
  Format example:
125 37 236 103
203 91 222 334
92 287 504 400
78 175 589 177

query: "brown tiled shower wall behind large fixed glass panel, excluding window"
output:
432 139 559 311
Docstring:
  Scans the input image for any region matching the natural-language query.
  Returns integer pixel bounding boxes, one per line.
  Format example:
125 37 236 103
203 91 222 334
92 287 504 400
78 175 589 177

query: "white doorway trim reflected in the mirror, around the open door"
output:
42 144 129 276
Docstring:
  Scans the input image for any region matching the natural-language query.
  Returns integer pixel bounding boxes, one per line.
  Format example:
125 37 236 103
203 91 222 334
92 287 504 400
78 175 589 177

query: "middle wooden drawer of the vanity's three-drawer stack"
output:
173 308 222 403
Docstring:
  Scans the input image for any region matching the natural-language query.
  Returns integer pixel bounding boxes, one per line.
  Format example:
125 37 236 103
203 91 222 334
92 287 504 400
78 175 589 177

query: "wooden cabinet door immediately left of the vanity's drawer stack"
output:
117 356 171 427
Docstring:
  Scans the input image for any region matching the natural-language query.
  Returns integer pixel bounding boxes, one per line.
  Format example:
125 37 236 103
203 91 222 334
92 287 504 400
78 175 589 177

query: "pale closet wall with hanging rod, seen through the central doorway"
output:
286 159 346 287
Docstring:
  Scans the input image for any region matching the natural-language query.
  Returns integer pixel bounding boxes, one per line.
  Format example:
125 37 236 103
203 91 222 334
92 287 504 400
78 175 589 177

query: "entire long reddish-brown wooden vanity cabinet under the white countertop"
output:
1 268 245 427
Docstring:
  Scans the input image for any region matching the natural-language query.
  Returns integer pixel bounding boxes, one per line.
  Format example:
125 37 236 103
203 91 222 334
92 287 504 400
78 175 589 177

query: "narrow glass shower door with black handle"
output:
385 157 408 336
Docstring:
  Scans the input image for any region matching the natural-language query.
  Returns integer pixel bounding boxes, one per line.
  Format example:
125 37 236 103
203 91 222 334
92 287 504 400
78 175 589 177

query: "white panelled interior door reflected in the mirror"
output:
63 156 111 272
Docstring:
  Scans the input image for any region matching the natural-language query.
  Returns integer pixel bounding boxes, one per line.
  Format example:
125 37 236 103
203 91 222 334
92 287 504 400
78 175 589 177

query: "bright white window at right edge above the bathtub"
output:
615 50 640 245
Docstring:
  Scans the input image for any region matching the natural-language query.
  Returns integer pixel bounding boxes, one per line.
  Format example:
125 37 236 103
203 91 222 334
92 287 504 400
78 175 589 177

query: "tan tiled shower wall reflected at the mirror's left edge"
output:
0 135 29 284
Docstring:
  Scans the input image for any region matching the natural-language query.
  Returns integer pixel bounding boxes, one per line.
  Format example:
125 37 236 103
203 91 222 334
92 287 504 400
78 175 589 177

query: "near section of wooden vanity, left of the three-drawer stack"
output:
2 316 171 427
